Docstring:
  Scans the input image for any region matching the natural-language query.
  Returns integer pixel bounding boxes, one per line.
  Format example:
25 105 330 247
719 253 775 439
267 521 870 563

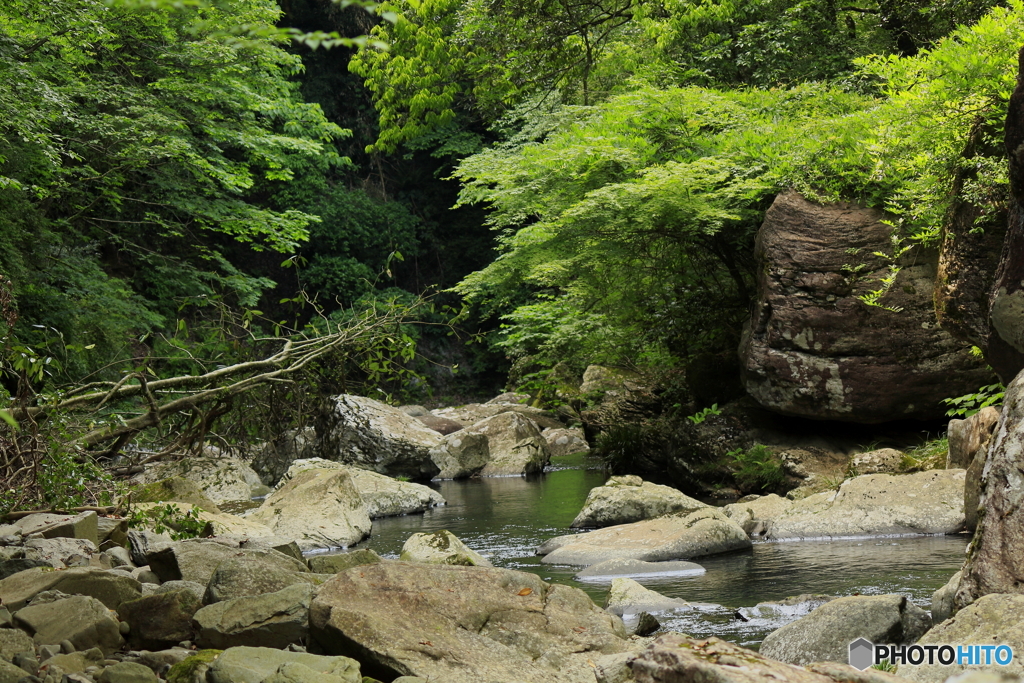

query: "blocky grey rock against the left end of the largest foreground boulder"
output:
193 584 312 649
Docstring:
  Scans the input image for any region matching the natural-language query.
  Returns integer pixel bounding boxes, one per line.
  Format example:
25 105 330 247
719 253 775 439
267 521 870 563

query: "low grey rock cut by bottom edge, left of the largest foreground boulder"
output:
206 647 362 683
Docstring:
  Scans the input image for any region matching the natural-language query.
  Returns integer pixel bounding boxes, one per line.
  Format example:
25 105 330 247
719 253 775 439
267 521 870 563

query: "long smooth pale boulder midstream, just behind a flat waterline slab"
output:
538 508 751 566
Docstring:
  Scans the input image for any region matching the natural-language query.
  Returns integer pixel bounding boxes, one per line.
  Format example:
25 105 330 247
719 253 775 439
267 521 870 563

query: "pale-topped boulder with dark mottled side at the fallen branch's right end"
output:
309 394 441 479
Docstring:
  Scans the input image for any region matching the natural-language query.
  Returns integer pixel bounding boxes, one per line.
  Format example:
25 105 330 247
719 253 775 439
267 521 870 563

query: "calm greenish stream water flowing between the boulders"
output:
333 456 968 648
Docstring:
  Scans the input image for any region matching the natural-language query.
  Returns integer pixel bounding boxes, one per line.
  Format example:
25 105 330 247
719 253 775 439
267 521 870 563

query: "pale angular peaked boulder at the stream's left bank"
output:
248 466 374 552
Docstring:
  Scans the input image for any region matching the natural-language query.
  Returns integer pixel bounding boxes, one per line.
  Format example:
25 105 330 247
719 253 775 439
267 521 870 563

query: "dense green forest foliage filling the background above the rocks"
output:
0 0 1024 510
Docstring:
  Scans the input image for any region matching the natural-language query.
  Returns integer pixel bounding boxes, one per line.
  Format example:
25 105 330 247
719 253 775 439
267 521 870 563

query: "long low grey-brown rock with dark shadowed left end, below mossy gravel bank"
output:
147 539 306 586
